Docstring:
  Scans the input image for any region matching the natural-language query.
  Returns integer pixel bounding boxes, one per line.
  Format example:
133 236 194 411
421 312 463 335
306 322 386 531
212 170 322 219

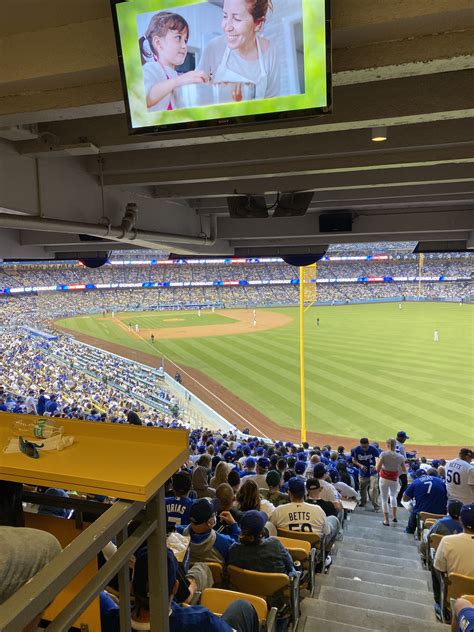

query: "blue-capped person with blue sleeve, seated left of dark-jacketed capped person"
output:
176 498 240 564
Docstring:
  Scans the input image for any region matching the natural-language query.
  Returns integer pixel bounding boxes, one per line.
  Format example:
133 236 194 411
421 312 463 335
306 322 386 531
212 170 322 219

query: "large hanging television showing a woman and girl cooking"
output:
112 0 331 133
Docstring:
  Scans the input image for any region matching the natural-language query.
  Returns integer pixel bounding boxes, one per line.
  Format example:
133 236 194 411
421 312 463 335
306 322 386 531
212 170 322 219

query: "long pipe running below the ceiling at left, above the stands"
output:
0 204 217 246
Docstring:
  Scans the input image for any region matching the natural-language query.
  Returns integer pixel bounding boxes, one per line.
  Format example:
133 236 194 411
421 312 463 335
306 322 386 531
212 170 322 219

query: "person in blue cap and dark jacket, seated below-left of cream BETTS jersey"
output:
229 510 295 575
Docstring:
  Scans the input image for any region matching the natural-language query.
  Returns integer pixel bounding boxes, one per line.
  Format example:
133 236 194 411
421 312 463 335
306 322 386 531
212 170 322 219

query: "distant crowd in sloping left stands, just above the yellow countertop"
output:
0 329 187 427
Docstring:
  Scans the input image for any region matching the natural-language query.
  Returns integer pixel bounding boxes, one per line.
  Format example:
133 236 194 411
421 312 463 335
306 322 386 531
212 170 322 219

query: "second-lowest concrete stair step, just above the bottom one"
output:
318 582 436 621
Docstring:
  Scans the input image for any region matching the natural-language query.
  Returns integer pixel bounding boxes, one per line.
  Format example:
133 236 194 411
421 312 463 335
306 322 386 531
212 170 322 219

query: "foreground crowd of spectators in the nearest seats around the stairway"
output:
0 422 474 632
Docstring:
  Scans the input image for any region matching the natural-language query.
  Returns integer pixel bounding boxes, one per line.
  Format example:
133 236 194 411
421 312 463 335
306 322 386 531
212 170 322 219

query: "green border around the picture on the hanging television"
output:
111 0 331 133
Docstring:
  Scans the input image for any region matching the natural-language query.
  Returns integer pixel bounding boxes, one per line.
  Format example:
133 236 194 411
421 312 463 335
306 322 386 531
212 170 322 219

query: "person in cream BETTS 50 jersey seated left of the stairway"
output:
270 477 341 563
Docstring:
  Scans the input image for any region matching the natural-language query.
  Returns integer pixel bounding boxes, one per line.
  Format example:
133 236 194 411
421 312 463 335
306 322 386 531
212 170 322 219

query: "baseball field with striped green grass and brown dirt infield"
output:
57 303 474 446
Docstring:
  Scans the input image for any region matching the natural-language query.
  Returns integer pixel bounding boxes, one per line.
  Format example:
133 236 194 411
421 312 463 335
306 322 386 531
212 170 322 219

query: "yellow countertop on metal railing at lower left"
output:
0 413 189 502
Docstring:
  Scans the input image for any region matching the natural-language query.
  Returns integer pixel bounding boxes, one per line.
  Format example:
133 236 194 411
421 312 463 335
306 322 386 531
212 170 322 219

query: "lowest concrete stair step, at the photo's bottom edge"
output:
301 598 448 632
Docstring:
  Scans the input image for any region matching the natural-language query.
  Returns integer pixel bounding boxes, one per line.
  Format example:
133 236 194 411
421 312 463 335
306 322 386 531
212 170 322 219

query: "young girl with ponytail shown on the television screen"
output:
139 11 208 112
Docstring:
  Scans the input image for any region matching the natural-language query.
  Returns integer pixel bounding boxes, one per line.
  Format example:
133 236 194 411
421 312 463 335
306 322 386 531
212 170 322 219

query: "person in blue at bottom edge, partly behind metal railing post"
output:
133 549 259 632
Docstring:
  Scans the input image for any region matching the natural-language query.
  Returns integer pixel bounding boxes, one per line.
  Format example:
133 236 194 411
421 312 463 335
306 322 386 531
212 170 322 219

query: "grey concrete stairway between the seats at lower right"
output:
298 508 449 632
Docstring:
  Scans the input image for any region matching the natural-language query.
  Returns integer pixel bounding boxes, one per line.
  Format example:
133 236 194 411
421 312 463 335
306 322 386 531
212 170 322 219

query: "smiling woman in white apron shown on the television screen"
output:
198 0 280 99
